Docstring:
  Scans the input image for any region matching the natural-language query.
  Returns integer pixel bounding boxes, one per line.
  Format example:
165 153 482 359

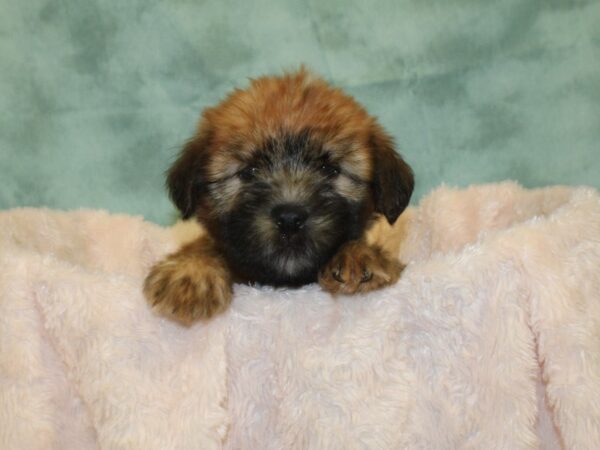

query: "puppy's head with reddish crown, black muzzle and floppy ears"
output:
167 69 414 285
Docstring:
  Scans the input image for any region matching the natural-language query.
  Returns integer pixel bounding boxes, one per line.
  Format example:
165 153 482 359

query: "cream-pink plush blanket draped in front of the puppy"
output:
0 183 600 450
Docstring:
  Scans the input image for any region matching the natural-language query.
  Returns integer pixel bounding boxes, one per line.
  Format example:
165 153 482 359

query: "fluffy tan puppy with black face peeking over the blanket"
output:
144 69 414 324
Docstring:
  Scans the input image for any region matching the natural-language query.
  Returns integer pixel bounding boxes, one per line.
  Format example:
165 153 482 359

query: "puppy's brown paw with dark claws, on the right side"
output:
319 241 404 295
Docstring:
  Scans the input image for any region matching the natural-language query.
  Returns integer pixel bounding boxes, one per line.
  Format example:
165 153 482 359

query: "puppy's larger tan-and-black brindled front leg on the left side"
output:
144 236 232 324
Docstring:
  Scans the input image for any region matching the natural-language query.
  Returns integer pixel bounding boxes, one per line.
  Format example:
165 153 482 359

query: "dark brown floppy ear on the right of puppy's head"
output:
369 125 415 224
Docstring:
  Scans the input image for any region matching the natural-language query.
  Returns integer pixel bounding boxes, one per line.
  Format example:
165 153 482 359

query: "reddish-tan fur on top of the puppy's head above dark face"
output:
199 69 374 183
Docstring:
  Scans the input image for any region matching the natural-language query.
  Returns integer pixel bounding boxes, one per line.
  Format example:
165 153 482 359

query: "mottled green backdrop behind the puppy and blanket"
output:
0 0 600 224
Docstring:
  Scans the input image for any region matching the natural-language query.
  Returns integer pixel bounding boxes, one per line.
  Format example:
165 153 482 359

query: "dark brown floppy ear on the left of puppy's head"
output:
167 125 210 219
